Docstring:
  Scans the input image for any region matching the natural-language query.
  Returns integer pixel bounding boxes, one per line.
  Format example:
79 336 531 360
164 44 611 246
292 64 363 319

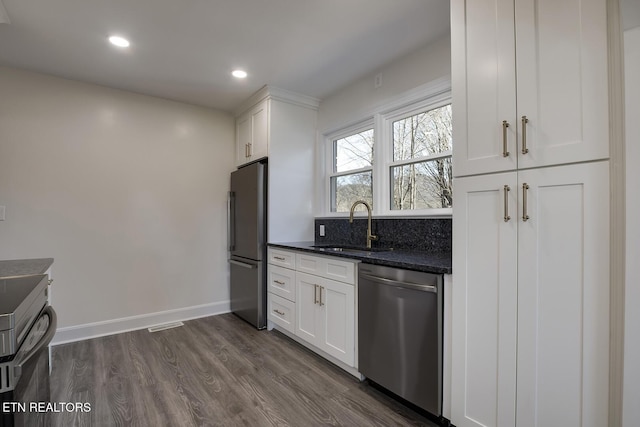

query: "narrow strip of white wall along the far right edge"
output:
623 25 640 427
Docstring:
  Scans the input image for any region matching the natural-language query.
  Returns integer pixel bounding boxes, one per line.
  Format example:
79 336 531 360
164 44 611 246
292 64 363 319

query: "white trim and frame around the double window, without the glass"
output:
316 78 455 218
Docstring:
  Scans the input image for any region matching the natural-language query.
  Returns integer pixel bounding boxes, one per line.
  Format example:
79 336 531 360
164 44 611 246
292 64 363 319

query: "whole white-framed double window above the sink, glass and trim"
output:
322 79 453 216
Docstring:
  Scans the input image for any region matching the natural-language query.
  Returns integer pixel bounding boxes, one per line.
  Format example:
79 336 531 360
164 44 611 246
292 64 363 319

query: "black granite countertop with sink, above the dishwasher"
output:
269 242 451 274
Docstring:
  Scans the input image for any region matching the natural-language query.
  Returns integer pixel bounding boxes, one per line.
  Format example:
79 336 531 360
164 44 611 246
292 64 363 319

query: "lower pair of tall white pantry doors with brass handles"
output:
451 161 609 427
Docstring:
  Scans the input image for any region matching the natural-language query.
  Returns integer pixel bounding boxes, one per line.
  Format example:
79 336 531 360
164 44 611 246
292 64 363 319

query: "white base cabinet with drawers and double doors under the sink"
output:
267 248 357 367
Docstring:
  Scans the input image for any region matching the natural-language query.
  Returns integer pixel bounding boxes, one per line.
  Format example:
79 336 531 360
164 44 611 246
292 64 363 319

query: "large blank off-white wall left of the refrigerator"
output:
0 67 234 339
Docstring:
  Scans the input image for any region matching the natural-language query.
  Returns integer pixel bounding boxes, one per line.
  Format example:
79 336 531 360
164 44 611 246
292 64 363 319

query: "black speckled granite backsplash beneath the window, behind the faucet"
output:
315 218 451 252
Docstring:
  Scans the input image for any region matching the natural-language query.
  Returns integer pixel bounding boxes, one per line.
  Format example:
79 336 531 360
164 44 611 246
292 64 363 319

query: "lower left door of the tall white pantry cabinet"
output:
451 172 520 427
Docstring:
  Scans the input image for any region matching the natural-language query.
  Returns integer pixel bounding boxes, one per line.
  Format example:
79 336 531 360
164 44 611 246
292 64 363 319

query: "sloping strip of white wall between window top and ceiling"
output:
318 35 451 132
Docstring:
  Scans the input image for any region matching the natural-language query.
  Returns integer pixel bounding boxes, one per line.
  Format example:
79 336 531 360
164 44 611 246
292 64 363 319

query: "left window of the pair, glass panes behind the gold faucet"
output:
330 129 373 212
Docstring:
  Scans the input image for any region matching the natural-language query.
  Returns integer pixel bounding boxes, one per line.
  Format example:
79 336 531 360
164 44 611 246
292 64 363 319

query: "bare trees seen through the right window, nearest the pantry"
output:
390 105 453 210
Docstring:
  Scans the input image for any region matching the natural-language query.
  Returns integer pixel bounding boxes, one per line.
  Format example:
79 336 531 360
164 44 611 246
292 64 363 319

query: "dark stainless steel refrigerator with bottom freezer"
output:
228 159 267 329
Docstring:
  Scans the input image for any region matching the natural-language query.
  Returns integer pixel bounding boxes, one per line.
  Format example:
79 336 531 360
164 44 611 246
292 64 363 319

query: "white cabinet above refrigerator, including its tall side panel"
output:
236 86 319 242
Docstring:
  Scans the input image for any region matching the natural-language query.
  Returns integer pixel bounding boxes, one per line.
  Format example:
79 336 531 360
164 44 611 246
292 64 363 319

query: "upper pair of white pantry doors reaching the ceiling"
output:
451 0 609 176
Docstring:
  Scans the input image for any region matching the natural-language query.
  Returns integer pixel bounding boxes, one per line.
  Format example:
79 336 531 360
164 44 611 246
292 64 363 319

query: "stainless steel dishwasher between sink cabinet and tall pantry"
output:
358 263 443 417
